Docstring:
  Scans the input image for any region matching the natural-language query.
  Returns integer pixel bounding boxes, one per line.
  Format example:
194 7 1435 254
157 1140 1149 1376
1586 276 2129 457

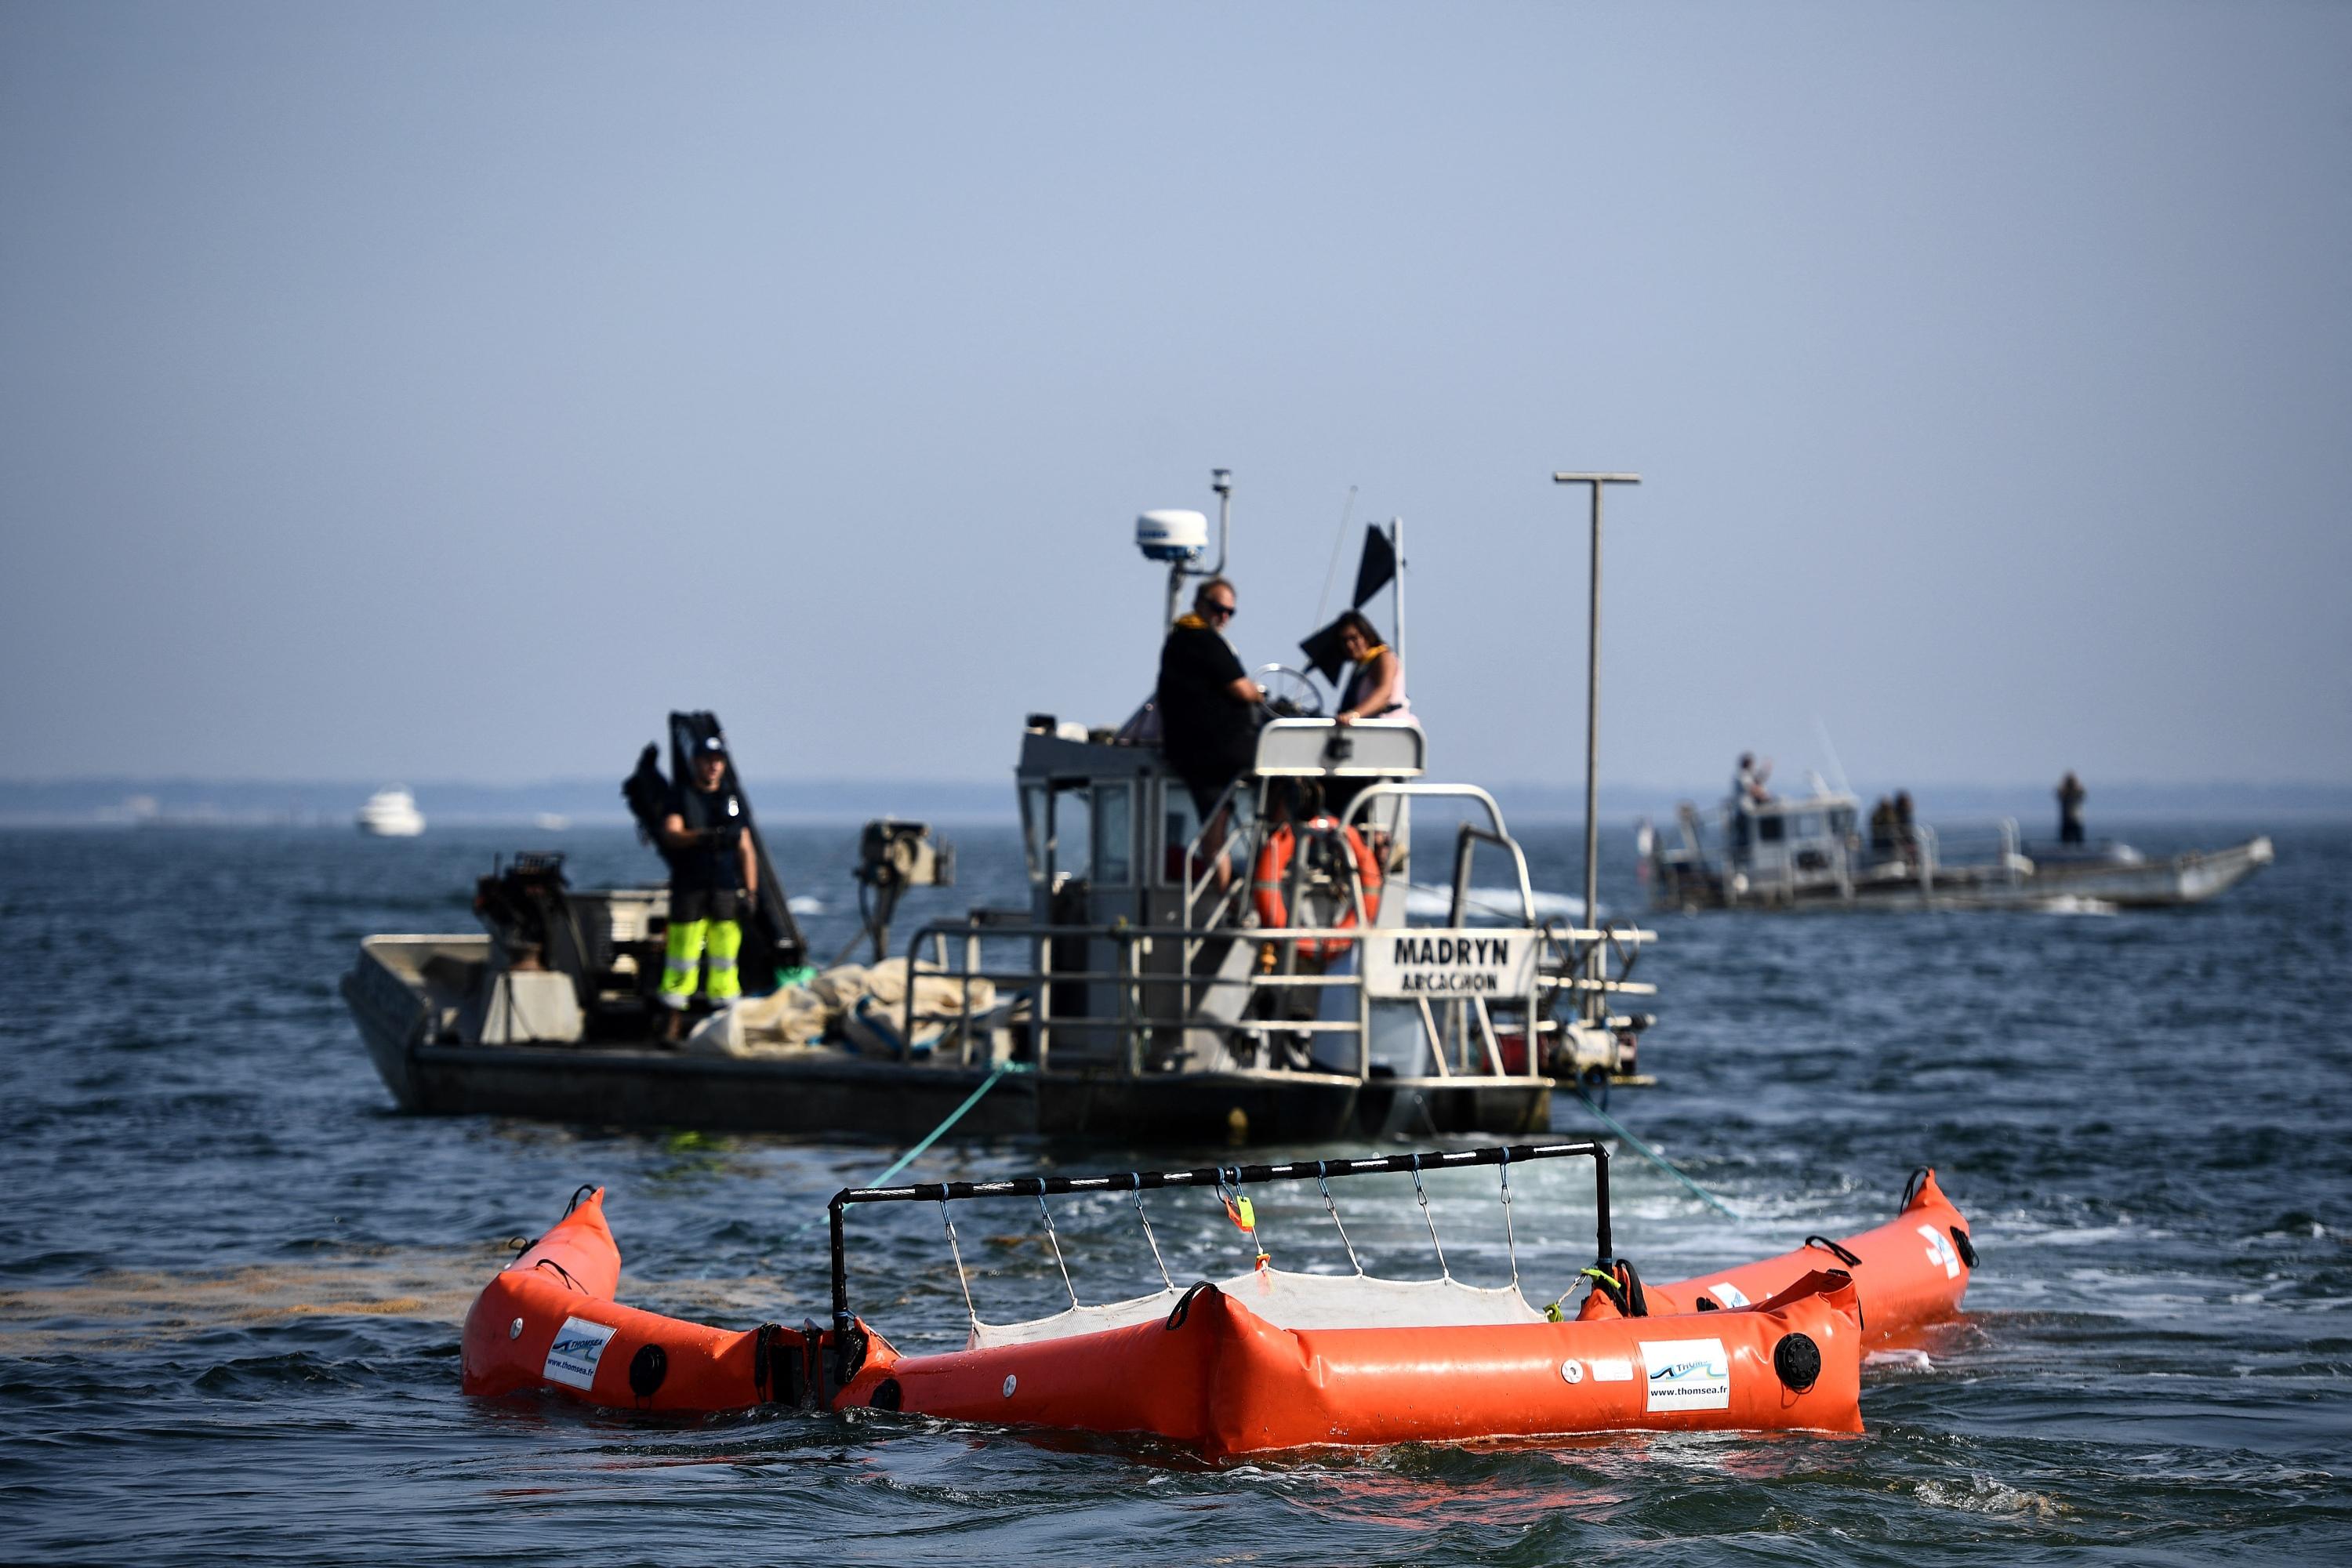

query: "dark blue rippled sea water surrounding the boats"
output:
0 822 2352 1568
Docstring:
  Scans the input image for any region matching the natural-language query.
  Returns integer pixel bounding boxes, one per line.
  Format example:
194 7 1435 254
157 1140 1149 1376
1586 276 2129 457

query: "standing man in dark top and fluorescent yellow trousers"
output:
661 736 760 1041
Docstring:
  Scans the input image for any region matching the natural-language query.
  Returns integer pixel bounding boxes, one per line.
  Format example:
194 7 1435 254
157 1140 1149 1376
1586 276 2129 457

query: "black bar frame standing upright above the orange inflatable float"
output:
826 1138 1616 1387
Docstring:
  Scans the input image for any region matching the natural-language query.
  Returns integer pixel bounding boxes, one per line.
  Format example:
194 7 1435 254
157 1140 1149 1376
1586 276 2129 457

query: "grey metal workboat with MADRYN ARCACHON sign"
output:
343 470 1656 1147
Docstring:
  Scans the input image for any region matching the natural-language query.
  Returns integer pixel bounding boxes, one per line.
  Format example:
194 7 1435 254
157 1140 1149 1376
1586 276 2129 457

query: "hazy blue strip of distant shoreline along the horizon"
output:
0 776 2352 834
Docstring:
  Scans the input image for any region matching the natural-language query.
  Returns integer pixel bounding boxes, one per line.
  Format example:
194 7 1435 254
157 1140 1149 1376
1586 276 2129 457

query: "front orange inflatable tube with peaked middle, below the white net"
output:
835 1269 1863 1460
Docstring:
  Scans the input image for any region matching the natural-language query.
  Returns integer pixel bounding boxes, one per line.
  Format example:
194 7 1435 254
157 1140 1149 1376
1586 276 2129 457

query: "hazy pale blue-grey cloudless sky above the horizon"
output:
0 0 2352 787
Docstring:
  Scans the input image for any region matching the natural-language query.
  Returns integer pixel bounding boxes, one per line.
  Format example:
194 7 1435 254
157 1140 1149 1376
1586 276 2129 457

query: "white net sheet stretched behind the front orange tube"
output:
964 1269 1543 1349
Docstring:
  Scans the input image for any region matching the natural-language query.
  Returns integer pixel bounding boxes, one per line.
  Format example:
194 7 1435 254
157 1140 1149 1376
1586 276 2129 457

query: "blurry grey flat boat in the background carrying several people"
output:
1642 779 2272 912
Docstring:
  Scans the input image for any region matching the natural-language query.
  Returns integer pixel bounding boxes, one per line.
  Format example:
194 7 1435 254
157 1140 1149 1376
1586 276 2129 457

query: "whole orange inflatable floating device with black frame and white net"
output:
461 1140 1978 1460
